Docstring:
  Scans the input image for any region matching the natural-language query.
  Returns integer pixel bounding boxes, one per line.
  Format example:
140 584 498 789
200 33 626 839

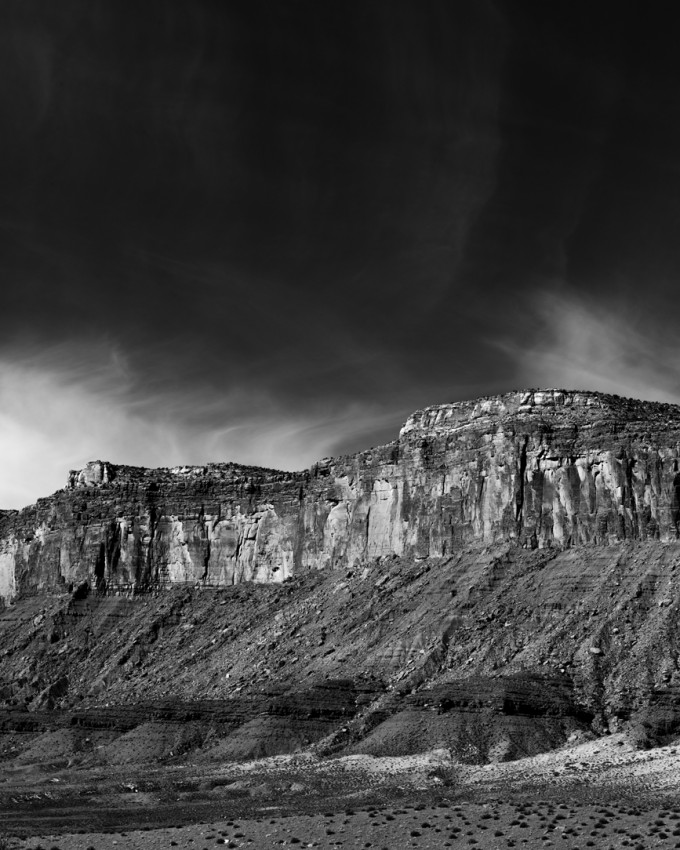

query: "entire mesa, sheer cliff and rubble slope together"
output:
0 390 680 764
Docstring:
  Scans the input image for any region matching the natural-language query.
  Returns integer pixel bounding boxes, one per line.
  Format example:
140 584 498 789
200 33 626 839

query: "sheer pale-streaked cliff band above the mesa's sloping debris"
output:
0 390 680 600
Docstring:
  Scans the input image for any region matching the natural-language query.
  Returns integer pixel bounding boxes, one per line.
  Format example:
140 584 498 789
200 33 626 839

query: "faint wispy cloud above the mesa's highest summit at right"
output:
508 293 680 403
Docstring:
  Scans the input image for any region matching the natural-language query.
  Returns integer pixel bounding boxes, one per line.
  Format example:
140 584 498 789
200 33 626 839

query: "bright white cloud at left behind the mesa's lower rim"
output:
0 342 406 508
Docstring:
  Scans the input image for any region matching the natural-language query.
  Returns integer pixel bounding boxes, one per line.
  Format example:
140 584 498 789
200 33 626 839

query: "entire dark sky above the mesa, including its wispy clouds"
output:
0 0 680 507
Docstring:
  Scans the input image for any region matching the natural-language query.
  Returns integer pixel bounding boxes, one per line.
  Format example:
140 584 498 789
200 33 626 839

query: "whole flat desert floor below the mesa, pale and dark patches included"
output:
0 733 680 850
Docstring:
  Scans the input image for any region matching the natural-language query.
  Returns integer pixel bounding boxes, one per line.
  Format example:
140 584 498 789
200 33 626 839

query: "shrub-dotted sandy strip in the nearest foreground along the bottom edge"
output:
10 801 680 850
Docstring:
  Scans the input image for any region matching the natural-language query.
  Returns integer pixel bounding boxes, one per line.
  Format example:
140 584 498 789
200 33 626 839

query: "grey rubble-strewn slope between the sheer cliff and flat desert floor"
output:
0 542 680 763
